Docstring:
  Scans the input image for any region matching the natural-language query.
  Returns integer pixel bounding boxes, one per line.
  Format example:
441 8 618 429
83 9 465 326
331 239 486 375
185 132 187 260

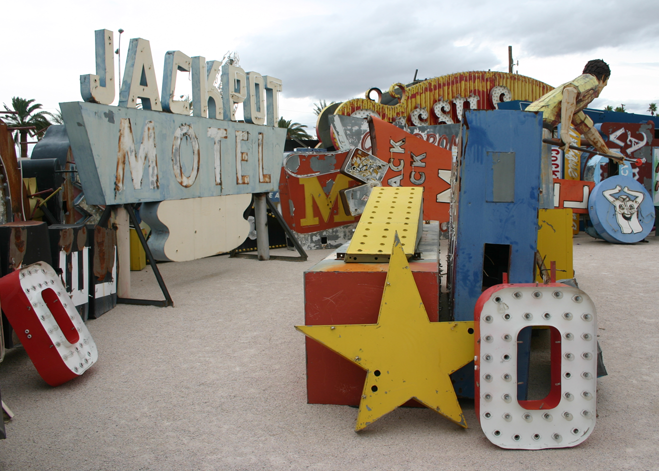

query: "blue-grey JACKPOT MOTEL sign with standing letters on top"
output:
61 30 286 204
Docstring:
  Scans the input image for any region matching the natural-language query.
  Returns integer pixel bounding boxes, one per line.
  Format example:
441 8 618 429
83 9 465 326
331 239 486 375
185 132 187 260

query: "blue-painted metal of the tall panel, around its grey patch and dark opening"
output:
450 110 542 321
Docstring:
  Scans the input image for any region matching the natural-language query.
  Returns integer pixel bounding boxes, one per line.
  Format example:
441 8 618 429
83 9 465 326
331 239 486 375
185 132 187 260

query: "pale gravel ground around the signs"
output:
0 235 659 470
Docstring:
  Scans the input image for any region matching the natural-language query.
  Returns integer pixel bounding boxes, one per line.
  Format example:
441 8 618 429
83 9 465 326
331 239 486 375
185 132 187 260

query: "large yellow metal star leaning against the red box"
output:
295 234 474 431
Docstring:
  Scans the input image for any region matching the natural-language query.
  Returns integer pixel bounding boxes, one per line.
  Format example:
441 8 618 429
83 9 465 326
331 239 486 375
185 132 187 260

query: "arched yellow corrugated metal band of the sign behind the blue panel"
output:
335 71 554 126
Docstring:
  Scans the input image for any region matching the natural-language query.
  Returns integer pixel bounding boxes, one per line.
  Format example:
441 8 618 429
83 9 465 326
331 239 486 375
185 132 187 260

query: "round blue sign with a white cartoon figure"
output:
588 175 655 244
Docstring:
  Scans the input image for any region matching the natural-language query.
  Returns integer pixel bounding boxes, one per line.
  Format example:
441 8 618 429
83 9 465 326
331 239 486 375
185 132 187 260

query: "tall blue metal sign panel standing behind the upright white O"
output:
448 110 542 399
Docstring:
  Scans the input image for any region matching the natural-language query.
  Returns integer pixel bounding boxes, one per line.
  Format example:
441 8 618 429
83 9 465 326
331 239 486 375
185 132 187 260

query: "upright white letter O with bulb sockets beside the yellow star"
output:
474 283 597 450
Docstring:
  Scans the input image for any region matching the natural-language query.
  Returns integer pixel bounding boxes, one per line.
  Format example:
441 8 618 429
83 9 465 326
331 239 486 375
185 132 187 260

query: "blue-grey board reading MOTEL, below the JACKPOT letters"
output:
60 102 286 205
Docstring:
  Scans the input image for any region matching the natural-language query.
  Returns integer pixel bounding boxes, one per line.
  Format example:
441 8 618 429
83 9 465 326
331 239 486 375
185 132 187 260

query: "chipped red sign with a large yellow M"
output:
279 152 360 234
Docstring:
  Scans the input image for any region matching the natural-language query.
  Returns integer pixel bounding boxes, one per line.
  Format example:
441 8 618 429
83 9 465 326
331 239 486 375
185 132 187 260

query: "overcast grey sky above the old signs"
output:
0 0 659 136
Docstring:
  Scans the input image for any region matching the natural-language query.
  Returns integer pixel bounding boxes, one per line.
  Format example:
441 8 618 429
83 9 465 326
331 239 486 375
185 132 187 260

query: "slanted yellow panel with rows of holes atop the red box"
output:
345 187 423 262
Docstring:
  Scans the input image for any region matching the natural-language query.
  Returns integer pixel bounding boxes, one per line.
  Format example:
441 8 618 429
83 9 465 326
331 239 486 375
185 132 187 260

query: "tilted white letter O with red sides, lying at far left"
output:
0 262 98 386
